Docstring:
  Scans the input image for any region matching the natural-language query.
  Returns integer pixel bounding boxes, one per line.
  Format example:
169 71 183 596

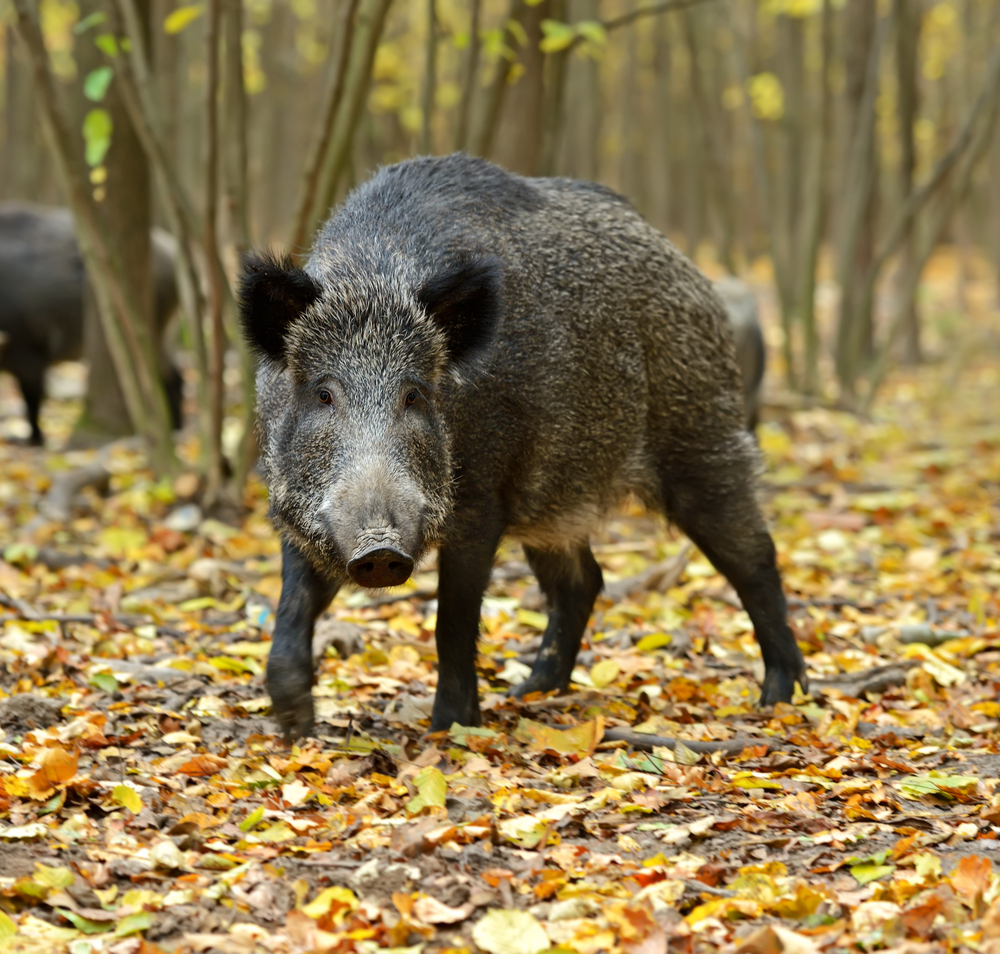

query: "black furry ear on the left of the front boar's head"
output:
240 252 321 361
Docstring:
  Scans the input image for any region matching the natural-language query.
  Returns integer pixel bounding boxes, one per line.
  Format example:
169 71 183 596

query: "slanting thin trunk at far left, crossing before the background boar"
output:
14 0 176 473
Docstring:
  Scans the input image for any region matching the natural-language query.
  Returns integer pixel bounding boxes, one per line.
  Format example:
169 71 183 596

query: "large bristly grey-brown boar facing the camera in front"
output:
242 155 805 736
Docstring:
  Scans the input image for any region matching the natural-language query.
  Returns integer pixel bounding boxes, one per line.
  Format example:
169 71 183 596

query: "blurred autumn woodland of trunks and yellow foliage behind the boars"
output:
0 0 1000 498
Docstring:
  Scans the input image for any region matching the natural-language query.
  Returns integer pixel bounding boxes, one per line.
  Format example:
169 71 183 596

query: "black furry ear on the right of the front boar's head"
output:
417 255 502 361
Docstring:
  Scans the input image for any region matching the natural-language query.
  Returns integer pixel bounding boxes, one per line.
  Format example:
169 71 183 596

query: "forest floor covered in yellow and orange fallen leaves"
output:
0 255 1000 954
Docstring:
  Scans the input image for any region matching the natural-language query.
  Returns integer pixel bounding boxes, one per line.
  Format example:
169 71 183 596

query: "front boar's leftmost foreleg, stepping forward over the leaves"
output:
267 541 340 739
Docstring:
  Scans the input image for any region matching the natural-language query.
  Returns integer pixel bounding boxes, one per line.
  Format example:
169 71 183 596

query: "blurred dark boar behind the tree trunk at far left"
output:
0 203 182 445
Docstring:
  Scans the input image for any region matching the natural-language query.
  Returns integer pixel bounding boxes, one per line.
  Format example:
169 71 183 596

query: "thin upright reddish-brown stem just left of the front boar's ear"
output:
204 0 226 506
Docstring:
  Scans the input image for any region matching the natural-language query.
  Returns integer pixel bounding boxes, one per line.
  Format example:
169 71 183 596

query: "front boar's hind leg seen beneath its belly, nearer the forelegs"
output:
511 546 604 697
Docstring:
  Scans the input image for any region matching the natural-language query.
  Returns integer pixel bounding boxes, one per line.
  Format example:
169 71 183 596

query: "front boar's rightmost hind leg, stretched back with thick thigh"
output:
664 446 807 706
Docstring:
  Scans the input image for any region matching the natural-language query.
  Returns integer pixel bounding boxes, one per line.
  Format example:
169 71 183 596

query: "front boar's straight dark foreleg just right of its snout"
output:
431 530 500 732
